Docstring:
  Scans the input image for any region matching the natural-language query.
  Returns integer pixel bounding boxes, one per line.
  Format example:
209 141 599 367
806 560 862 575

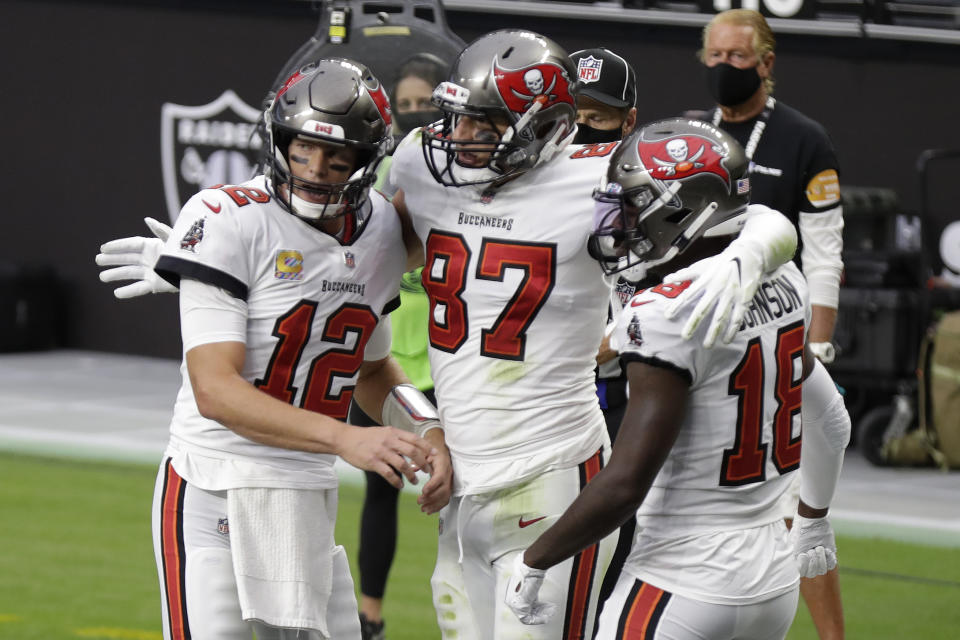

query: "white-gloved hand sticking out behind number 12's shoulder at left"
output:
97 218 177 300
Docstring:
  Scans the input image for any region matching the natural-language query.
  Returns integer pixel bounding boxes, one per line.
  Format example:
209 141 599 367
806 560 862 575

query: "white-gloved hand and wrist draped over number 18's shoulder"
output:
664 204 797 348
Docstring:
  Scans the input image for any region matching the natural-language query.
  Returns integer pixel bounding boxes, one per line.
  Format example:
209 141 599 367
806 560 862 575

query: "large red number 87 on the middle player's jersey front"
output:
423 232 557 360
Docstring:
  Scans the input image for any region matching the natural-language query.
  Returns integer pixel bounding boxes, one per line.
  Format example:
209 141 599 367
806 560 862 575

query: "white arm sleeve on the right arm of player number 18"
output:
800 361 850 509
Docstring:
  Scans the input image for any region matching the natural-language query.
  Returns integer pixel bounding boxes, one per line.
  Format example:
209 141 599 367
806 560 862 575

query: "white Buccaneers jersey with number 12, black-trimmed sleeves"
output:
157 176 407 490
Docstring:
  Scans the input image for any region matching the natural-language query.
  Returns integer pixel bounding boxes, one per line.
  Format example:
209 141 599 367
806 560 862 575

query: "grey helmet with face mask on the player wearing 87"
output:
423 30 577 186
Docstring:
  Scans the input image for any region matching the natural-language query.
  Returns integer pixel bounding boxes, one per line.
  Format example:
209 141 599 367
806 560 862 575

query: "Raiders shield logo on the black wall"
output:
160 89 263 223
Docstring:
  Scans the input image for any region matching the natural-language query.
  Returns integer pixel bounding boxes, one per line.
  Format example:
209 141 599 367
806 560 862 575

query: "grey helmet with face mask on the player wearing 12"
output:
264 58 392 221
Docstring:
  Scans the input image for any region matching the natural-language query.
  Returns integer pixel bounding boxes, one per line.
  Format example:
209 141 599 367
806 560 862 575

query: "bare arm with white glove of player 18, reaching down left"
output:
505 362 689 624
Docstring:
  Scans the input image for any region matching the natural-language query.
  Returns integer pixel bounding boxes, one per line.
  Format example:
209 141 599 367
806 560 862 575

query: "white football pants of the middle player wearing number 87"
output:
431 451 617 640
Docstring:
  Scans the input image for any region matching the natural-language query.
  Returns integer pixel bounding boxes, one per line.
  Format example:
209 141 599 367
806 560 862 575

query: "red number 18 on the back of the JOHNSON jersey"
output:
720 322 803 487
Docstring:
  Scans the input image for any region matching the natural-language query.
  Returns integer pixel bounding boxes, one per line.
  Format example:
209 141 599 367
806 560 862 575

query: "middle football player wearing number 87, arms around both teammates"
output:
97 30 796 640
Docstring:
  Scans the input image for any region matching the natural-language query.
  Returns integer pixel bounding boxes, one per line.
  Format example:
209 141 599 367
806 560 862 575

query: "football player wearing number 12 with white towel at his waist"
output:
102 59 451 640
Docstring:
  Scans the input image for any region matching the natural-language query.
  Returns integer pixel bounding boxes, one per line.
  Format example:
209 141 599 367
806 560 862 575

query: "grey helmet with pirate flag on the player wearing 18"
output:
589 118 750 274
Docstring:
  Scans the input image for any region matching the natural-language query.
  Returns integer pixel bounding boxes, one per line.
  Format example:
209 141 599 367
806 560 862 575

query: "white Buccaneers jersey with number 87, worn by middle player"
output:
391 136 616 494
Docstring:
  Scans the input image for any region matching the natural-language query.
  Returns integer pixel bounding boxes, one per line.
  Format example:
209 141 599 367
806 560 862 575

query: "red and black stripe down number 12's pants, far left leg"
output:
160 459 190 640
